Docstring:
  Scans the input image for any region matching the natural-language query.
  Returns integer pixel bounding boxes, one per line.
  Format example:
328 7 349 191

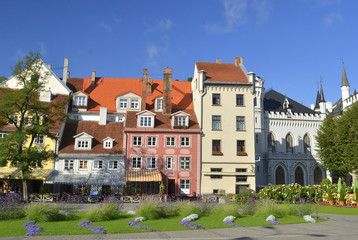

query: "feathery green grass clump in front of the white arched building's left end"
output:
255 199 288 218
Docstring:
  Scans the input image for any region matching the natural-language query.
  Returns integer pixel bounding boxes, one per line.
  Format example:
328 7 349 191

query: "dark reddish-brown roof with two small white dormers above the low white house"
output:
59 121 123 154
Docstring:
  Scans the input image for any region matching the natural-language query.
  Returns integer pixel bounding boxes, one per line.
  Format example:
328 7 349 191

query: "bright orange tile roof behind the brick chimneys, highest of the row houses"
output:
67 78 193 112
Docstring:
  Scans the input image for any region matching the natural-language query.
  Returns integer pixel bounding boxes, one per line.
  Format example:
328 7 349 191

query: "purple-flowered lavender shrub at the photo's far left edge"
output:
0 193 25 220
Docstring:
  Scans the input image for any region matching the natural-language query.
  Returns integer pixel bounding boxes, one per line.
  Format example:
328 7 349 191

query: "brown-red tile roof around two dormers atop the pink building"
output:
126 109 200 130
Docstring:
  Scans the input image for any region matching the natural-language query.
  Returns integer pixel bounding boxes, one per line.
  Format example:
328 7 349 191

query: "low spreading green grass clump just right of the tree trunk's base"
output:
25 203 76 222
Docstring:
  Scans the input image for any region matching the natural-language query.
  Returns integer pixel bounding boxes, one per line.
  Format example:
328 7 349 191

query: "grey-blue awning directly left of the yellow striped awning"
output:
87 172 125 186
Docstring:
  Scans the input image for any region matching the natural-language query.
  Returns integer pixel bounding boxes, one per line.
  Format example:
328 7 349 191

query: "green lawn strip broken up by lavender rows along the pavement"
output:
0 212 322 237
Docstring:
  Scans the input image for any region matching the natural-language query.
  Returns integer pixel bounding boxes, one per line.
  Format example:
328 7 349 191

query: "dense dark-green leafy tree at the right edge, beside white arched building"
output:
316 102 358 175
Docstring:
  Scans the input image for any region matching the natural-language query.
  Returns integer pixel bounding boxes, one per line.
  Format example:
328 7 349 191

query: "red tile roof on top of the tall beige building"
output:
196 62 248 83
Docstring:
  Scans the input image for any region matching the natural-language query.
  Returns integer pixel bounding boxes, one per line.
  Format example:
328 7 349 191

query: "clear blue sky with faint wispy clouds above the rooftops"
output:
0 0 358 106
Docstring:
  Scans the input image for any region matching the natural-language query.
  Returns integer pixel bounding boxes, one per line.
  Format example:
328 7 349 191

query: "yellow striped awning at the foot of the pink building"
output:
124 169 162 182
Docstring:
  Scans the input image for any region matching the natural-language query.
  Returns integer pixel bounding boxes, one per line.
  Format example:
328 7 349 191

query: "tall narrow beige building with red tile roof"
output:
192 57 256 194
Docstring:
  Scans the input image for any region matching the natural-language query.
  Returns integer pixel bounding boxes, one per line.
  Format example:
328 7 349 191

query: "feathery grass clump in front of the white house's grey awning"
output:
86 197 127 222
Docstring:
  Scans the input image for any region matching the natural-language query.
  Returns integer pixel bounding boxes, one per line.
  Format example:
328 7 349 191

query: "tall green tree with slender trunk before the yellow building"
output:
0 52 67 201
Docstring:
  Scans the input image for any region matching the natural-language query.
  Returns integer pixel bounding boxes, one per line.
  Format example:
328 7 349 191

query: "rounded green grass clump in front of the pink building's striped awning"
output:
137 200 166 219
